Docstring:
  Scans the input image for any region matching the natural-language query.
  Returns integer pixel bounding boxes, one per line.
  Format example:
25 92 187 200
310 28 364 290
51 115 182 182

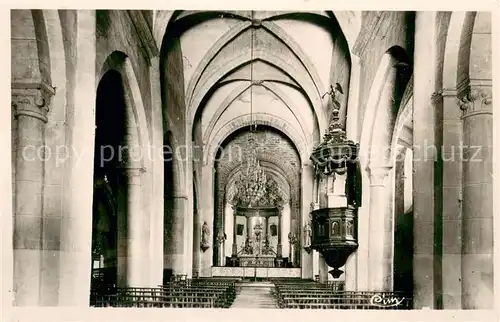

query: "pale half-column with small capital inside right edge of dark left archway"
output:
126 168 149 287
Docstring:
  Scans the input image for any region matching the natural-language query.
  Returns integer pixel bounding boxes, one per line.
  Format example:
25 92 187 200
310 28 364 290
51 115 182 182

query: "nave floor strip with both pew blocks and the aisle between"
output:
90 276 412 310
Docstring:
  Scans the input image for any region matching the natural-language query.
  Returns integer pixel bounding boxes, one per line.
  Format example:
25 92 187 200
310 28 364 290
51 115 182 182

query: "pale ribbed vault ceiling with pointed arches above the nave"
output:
159 11 352 194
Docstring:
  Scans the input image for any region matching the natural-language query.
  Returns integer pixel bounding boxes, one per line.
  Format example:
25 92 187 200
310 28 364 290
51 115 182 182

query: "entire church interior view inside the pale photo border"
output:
10 10 494 309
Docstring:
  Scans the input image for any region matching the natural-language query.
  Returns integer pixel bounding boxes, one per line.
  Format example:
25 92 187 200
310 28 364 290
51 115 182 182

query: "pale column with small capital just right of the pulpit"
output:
368 166 392 291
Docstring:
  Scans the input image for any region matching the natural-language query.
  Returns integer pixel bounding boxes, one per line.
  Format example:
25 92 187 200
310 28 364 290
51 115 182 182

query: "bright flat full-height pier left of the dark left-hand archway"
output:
59 10 97 307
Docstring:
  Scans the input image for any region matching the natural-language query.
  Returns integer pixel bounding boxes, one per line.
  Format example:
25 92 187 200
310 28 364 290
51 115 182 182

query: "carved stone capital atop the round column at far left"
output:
11 83 55 123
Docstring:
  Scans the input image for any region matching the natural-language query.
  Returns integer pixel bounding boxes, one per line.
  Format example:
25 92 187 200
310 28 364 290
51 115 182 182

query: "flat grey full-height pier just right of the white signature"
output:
413 11 440 309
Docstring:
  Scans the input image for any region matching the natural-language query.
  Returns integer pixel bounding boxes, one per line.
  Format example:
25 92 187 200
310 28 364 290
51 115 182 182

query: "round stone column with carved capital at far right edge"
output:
460 83 494 309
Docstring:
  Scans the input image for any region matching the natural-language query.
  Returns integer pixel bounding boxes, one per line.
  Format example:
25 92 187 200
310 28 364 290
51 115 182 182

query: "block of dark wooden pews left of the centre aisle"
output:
90 278 239 308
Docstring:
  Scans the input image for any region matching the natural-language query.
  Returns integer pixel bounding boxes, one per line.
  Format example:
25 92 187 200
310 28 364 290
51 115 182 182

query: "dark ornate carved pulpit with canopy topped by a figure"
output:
307 84 361 278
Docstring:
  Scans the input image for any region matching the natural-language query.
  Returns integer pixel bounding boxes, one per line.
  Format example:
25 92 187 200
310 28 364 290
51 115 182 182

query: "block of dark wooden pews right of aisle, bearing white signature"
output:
273 279 412 310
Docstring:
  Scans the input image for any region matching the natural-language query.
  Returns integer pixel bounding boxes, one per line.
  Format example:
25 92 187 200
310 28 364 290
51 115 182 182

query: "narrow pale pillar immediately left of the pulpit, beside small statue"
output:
298 164 314 279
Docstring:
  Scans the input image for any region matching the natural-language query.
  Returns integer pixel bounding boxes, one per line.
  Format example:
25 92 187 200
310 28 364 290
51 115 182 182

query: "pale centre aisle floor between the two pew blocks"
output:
231 282 277 309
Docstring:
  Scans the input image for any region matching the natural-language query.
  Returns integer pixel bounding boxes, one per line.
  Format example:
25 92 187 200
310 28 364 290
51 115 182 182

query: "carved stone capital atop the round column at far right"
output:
457 85 493 118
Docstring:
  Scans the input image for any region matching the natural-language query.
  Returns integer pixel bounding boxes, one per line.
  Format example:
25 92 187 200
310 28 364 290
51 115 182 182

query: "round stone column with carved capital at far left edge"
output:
12 84 54 306
